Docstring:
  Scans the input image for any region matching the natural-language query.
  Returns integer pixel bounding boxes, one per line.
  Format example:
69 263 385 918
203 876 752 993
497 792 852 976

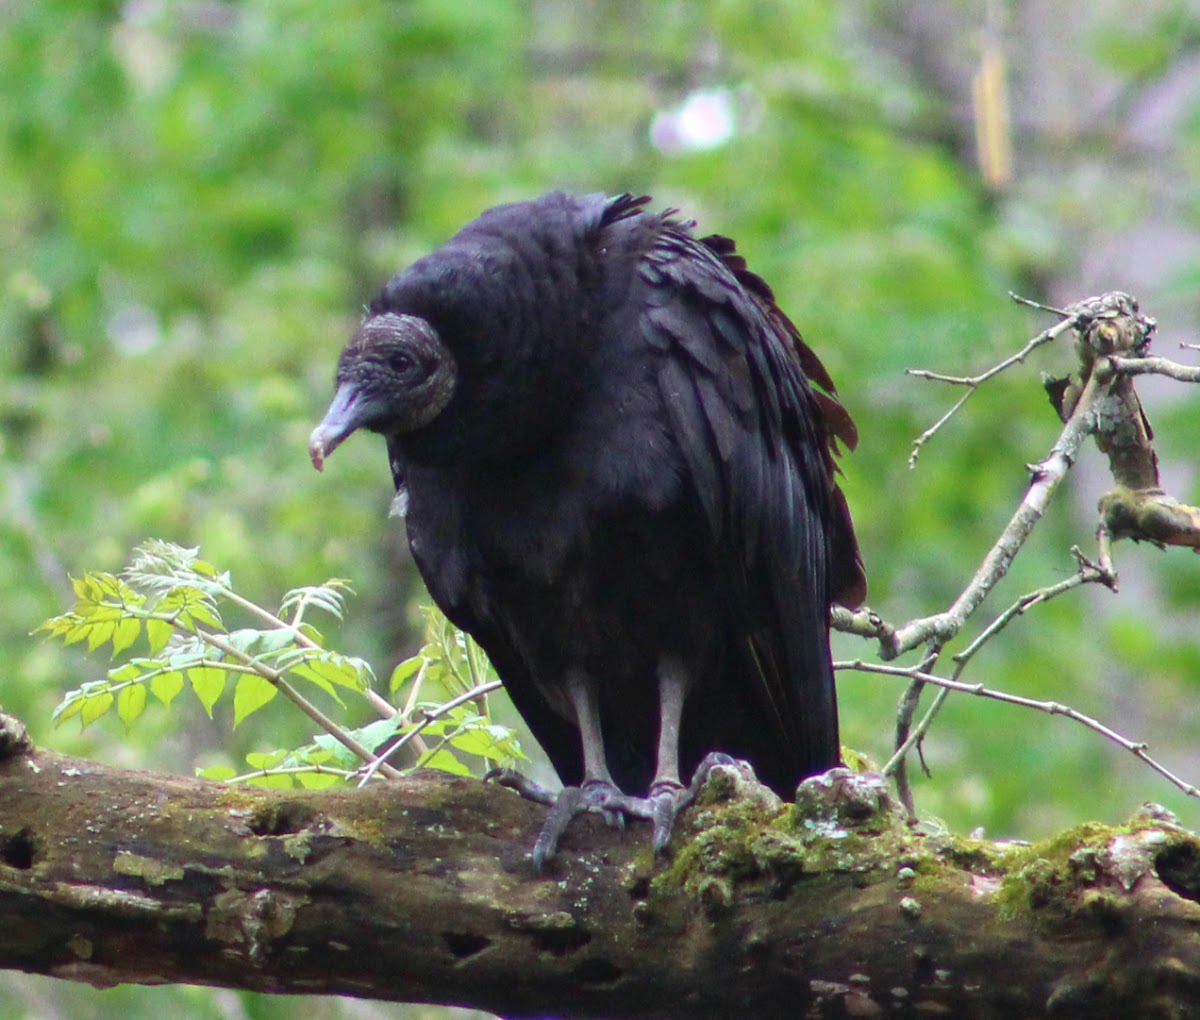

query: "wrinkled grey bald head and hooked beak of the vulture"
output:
308 312 458 470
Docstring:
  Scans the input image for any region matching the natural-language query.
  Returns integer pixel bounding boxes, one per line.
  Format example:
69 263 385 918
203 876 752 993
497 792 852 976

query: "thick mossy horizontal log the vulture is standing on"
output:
0 716 1200 1018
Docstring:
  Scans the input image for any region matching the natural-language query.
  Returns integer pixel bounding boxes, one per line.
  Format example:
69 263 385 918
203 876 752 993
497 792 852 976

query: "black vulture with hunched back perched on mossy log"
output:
310 192 866 869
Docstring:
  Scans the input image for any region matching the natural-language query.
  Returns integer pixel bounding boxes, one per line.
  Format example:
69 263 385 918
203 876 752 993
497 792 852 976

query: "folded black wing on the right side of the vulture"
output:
638 220 863 785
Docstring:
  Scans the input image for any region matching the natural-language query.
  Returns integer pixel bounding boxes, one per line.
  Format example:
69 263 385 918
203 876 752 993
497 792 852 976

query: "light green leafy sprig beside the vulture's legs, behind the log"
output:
35 540 522 786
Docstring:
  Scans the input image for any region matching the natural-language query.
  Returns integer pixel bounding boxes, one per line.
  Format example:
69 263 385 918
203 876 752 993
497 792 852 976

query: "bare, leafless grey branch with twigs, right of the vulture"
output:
849 292 1200 814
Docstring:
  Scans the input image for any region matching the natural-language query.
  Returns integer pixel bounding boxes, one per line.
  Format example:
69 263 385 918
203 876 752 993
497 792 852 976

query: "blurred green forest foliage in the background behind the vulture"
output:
0 0 1200 1020
